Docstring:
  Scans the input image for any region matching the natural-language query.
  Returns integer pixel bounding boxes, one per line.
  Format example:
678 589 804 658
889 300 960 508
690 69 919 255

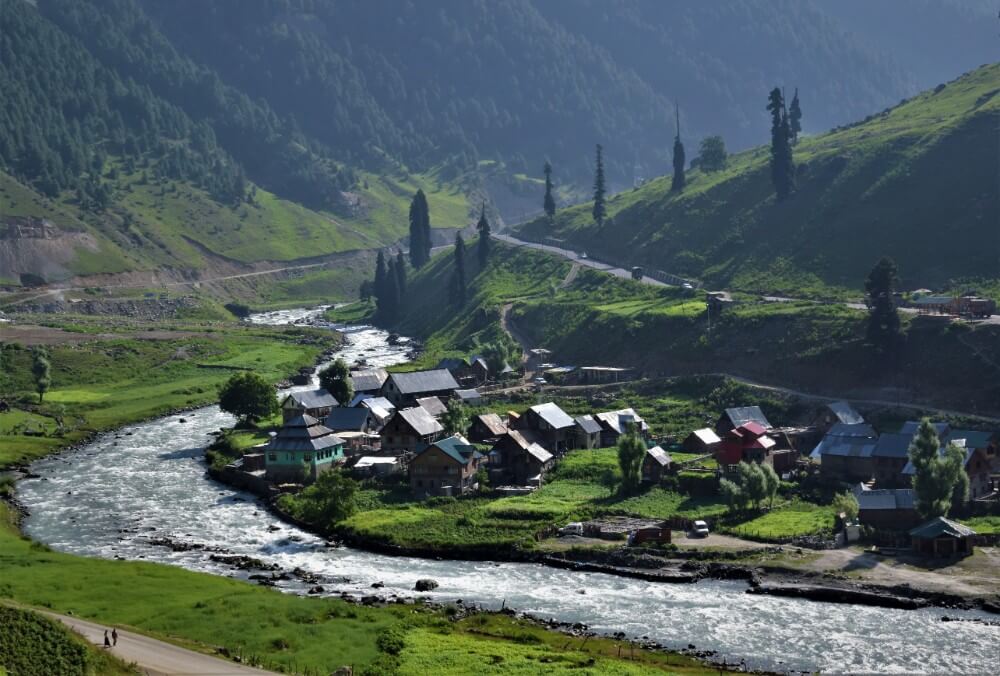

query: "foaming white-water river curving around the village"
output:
18 310 1000 674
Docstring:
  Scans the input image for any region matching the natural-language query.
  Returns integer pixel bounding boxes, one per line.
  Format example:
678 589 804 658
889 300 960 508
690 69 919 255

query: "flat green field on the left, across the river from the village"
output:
0 319 338 468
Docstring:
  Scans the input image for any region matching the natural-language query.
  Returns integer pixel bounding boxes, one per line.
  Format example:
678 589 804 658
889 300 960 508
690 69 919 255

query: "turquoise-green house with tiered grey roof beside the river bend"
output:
263 415 344 483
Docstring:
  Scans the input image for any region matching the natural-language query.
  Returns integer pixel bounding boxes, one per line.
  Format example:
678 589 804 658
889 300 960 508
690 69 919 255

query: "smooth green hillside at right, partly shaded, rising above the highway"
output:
520 64 1000 294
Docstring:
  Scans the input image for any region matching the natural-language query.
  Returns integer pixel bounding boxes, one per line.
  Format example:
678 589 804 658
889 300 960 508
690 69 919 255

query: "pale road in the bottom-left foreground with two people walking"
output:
45 613 275 676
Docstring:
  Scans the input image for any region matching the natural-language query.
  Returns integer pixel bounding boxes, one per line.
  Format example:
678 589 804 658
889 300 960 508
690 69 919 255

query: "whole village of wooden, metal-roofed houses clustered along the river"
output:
219 340 1000 572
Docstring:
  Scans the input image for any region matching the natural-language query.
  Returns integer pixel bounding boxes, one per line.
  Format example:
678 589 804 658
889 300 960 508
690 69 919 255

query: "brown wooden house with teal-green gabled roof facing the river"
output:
410 435 483 497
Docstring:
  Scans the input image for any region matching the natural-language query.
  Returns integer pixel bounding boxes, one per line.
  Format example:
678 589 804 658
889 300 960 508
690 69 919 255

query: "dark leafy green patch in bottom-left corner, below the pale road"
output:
0 605 138 676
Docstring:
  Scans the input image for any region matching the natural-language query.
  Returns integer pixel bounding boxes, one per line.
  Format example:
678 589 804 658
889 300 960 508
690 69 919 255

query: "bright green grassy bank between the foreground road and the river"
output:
0 502 712 674
